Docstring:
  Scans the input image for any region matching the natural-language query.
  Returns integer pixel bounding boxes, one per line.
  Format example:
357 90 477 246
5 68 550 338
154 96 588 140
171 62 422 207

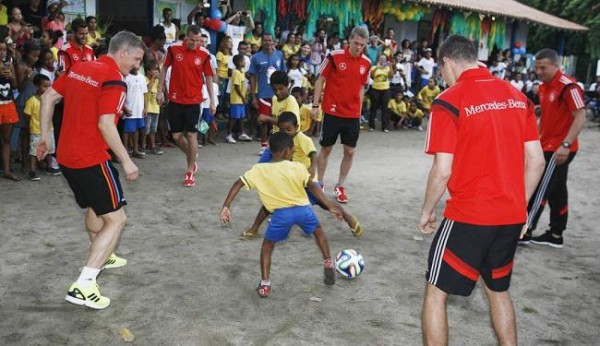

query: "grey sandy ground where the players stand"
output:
0 121 600 345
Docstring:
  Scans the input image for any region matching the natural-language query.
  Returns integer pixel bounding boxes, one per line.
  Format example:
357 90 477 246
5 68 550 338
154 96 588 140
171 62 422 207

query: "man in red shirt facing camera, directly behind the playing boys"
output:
312 26 371 203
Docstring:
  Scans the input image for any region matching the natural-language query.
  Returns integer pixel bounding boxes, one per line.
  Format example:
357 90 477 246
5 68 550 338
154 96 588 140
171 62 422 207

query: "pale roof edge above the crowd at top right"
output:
416 0 589 31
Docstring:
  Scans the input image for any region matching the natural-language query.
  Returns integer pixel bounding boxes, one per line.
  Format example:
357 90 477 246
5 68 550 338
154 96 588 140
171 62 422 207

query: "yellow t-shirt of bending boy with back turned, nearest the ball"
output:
240 161 310 212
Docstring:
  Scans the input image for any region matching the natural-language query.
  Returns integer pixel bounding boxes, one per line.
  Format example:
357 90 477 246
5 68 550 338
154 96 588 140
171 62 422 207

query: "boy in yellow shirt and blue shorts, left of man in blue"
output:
225 54 252 143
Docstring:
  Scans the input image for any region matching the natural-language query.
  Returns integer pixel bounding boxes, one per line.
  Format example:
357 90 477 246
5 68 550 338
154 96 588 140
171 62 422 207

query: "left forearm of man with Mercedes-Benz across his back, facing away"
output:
419 153 454 234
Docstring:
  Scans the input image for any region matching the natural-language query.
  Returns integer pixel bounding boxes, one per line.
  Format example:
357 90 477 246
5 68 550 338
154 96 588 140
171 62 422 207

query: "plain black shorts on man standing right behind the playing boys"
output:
319 113 360 148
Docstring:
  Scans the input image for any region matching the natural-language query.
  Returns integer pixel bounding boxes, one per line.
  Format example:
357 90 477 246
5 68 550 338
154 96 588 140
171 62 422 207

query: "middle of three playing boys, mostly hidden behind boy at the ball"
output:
240 112 363 240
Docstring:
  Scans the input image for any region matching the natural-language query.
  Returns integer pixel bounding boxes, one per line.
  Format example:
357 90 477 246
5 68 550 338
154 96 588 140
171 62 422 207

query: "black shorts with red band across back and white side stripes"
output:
426 219 523 296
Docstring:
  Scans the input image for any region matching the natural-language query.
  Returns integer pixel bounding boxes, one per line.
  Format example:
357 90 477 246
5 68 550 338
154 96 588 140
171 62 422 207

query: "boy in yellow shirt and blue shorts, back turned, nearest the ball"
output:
220 132 342 298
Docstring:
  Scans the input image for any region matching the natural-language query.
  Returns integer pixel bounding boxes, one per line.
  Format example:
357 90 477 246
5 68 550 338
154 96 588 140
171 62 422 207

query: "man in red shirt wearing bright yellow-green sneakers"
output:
37 31 144 309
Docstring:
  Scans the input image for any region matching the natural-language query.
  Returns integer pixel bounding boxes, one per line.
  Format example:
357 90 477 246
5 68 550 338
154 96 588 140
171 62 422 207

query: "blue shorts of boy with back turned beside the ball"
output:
265 205 319 243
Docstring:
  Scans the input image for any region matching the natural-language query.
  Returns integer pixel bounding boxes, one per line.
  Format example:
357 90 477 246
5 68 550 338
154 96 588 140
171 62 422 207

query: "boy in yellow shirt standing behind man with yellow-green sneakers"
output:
23 73 60 181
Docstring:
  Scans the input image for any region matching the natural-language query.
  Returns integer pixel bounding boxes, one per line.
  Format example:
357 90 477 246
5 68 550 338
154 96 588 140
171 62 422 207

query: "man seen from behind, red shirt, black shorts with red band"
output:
419 36 544 345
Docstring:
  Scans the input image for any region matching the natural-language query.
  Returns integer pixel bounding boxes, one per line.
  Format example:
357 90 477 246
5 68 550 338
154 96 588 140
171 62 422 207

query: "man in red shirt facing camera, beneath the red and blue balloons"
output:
156 25 216 187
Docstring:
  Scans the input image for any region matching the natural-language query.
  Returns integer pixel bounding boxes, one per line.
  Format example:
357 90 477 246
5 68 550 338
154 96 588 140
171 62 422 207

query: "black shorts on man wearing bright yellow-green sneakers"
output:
60 161 127 216
